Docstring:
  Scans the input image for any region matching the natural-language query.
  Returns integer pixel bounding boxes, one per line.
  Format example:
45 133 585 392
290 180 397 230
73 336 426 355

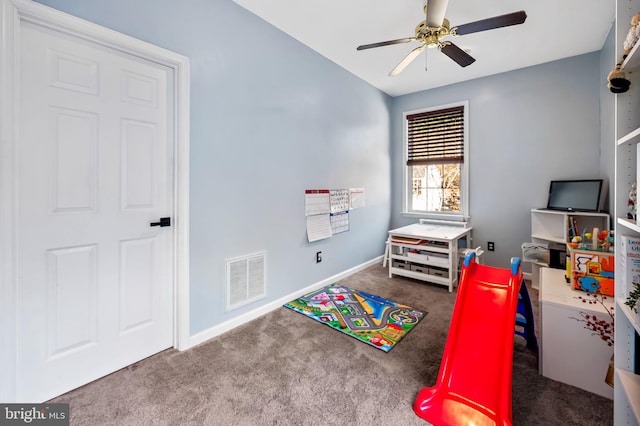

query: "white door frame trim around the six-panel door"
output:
0 0 190 402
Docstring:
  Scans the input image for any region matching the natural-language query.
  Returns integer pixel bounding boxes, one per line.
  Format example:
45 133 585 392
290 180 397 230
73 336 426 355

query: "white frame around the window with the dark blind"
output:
402 101 471 222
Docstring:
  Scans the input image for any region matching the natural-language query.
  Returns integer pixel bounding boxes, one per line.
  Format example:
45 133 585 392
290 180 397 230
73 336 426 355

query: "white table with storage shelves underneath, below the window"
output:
387 223 472 291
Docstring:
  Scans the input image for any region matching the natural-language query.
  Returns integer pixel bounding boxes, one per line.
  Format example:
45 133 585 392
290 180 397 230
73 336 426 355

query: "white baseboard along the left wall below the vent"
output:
186 256 383 351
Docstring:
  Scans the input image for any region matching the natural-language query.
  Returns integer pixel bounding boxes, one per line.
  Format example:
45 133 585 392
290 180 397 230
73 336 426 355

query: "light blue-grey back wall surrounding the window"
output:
391 52 613 269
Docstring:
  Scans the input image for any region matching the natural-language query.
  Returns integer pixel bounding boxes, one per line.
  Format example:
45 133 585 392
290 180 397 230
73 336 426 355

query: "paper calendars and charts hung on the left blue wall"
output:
305 188 364 243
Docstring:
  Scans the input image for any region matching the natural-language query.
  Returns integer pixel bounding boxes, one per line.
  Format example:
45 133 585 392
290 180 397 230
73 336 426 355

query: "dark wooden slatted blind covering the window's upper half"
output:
407 106 464 166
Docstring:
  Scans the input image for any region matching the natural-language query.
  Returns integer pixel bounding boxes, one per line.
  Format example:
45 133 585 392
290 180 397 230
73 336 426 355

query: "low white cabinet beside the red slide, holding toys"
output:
538 268 613 399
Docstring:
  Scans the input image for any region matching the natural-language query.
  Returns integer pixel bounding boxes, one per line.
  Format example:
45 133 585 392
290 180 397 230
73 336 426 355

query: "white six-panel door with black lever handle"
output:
17 19 174 402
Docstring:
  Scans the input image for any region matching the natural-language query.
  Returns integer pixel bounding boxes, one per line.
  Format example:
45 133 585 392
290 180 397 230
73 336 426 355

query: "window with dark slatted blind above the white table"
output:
404 102 469 220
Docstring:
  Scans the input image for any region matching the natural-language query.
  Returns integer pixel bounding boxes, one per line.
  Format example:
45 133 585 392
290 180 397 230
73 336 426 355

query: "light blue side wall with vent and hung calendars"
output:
40 0 391 333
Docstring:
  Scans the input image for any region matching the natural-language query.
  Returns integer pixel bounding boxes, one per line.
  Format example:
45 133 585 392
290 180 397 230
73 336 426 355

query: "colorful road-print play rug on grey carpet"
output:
284 284 427 352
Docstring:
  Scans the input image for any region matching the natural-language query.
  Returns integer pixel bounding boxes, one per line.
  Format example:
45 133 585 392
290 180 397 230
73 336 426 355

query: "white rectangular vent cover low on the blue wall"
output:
226 252 266 311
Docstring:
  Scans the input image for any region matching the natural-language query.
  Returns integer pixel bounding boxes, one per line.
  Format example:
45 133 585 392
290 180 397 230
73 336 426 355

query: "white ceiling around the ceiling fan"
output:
234 0 615 96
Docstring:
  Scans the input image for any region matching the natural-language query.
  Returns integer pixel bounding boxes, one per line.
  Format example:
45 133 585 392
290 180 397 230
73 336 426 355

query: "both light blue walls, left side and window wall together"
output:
32 0 613 333
